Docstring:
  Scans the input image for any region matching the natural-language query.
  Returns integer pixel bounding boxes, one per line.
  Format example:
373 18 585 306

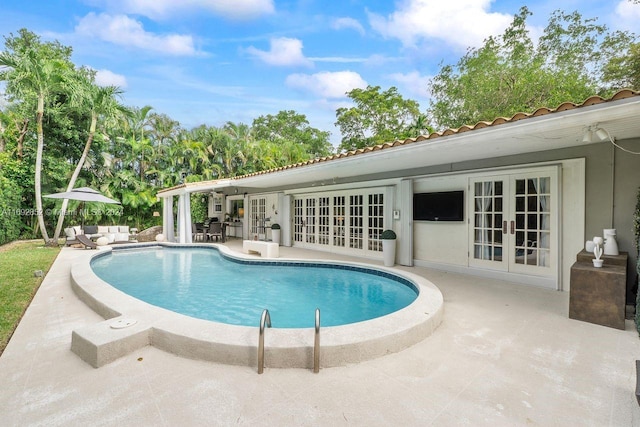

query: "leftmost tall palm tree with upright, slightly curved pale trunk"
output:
0 29 73 244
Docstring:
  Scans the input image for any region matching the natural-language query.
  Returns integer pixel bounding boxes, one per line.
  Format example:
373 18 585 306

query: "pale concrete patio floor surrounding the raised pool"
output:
0 240 640 426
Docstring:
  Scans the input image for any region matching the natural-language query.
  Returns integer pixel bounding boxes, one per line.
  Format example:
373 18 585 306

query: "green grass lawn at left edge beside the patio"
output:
0 240 60 354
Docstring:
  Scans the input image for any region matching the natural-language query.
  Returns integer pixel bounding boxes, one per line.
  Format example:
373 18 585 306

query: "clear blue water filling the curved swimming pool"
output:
91 247 417 328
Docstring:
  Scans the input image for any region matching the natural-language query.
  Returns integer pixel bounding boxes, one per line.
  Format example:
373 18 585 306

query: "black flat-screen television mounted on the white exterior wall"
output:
413 190 464 221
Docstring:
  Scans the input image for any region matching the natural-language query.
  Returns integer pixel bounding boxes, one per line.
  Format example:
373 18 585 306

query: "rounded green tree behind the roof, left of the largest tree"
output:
335 86 420 150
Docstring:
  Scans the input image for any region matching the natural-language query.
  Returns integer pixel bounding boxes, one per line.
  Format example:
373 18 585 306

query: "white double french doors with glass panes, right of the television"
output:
468 167 558 277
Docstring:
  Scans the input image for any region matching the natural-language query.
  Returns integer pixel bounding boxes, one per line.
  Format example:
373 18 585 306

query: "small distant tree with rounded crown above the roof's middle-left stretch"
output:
252 110 333 157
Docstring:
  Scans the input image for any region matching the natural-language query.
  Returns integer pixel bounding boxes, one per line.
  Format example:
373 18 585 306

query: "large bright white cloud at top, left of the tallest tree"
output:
369 0 513 48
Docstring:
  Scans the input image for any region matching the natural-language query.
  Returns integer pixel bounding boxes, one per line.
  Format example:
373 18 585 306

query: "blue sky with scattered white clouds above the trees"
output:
0 0 640 143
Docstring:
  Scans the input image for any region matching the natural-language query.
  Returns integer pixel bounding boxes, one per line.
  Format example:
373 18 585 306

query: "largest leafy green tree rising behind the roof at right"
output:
428 7 635 128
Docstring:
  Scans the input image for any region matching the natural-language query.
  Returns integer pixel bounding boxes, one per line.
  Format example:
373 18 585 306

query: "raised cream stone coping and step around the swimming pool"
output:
71 242 444 369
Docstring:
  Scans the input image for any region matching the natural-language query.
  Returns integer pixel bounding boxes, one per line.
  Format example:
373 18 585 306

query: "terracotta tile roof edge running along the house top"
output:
161 89 640 192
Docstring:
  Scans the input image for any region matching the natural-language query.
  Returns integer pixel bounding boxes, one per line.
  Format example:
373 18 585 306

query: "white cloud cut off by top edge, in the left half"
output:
85 0 275 20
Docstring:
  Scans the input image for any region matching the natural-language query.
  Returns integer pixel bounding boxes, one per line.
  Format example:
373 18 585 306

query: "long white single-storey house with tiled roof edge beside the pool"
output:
158 90 640 300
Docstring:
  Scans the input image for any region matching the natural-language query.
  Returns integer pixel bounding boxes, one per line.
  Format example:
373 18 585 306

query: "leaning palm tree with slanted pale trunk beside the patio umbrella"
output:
53 69 126 242
